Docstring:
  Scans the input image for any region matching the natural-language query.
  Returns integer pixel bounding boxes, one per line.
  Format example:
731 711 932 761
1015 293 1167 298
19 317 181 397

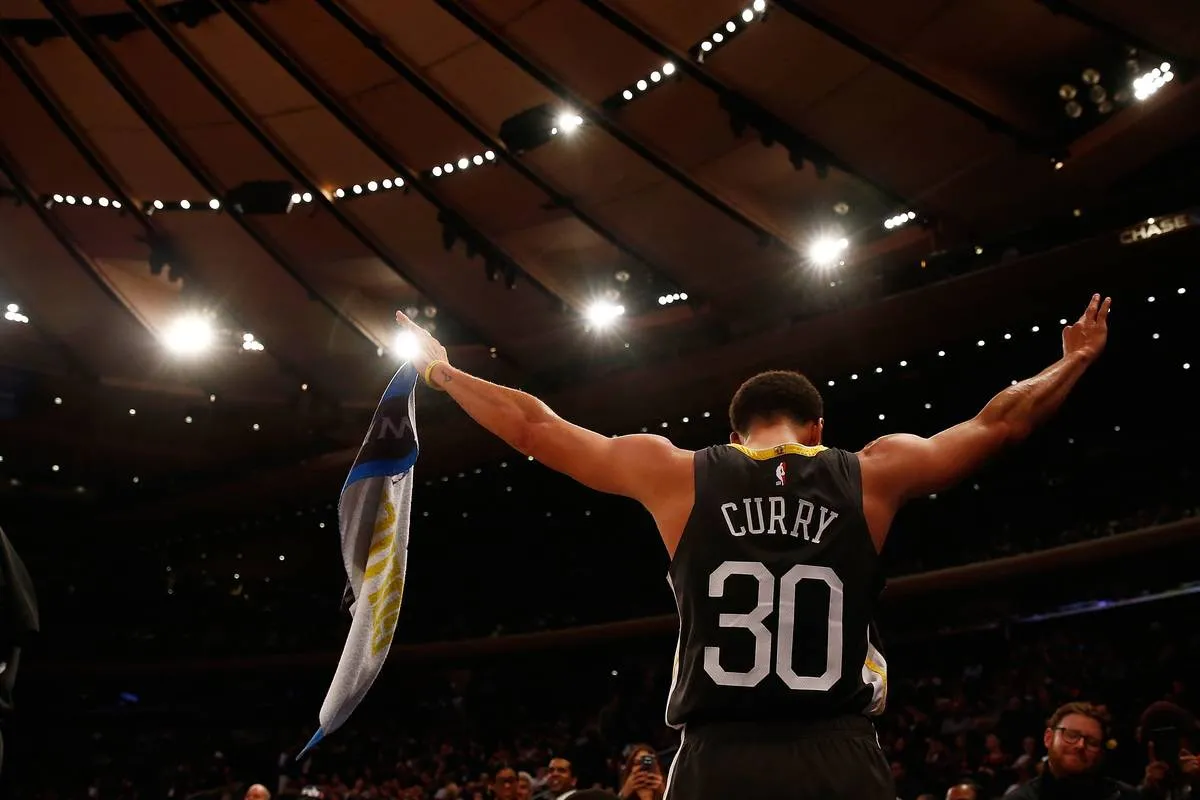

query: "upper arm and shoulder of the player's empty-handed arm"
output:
859 416 1025 504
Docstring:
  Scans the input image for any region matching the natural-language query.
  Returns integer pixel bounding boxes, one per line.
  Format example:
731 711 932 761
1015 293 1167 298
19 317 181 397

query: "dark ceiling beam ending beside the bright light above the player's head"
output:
433 0 796 252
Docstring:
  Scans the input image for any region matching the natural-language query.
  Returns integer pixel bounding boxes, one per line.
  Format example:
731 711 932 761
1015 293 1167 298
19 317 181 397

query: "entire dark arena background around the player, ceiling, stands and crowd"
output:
0 0 1200 800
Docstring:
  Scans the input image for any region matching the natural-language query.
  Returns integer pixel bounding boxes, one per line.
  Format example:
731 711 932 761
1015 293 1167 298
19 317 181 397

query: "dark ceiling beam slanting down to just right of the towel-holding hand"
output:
126 0 525 366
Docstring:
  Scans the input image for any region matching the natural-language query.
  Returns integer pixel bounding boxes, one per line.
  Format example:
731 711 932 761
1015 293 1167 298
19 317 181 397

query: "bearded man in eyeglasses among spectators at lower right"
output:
1006 703 1141 800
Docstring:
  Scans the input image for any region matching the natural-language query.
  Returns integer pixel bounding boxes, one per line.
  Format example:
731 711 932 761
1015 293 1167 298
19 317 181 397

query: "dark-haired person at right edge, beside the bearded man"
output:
1138 700 1200 800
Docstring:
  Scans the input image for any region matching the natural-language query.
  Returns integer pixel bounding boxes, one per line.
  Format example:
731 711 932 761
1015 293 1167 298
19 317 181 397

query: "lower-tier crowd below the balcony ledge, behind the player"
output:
13 587 1200 800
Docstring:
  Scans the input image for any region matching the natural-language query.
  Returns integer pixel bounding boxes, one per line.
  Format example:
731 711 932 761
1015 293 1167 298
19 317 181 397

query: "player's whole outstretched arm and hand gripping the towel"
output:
396 312 692 513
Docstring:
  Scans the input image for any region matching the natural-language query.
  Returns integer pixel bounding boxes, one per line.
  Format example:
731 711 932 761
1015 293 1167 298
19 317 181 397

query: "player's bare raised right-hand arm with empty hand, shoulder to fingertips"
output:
858 295 1111 547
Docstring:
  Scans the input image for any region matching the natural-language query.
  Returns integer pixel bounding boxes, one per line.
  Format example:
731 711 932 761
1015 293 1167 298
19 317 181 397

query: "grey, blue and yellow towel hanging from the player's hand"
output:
296 363 419 759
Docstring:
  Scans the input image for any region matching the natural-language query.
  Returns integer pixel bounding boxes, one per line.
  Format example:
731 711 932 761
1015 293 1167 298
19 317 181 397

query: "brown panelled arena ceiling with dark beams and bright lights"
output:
0 0 1200 513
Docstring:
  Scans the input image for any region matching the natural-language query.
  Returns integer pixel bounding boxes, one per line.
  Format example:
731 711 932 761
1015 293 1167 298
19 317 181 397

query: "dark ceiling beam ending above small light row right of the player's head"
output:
578 0 914 207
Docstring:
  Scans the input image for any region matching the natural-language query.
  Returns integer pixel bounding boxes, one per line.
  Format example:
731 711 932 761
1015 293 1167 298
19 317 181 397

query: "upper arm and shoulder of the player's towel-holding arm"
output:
516 416 692 511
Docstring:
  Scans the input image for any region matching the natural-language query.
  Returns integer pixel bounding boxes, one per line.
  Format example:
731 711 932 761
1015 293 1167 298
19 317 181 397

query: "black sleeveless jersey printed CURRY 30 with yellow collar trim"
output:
666 444 887 727
